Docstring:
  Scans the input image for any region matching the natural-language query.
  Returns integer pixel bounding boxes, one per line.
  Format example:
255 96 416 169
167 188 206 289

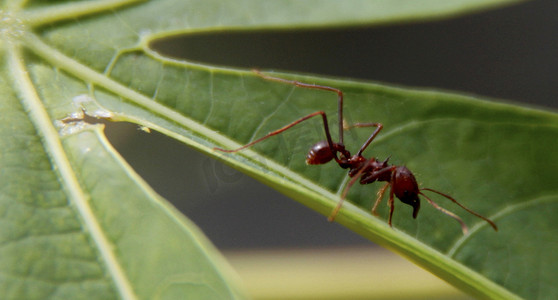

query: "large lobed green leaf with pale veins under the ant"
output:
0 0 558 299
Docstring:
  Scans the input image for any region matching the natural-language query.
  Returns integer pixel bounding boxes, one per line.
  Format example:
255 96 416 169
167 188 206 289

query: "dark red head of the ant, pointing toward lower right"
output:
393 167 420 218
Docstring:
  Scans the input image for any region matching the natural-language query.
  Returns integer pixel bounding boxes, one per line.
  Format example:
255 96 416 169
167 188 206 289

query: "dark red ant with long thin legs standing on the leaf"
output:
214 70 498 234
